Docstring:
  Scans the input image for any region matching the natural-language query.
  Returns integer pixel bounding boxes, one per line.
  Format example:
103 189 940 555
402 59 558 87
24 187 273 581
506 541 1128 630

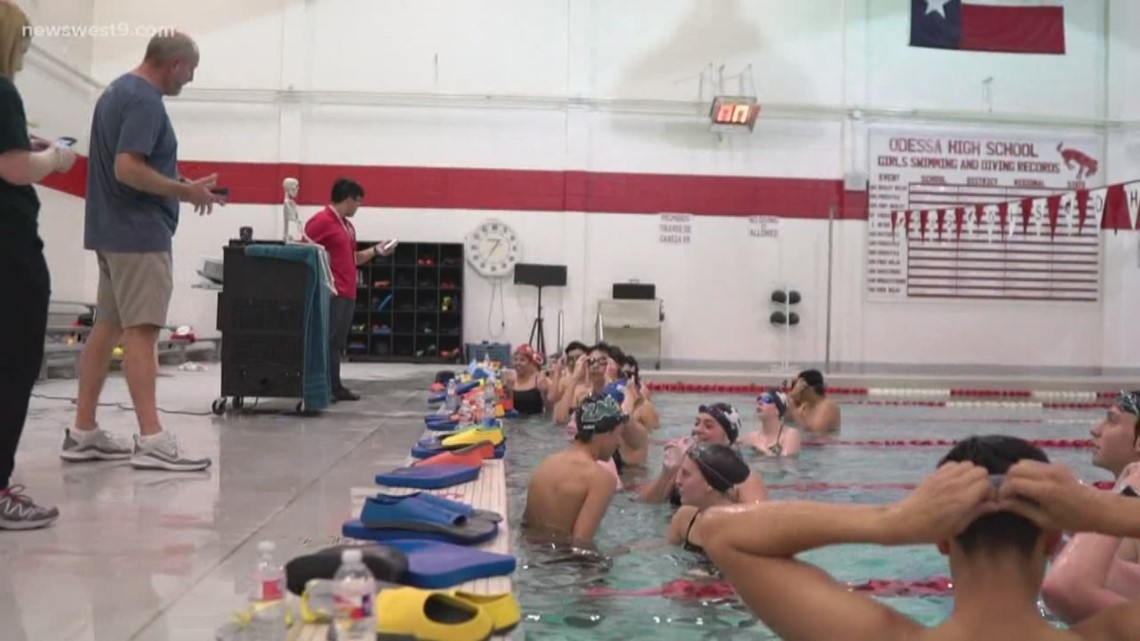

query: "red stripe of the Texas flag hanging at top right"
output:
960 2 1065 54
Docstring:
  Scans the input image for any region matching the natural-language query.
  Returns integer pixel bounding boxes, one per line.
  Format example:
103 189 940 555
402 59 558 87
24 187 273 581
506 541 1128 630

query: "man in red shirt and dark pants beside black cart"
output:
304 178 391 400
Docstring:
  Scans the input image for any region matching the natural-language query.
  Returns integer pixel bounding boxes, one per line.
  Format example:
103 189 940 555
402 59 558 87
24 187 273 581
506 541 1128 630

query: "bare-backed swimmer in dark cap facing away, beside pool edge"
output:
522 395 629 545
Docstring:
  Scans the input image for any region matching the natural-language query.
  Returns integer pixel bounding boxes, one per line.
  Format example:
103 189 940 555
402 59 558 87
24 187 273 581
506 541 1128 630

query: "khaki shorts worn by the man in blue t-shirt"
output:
96 251 174 330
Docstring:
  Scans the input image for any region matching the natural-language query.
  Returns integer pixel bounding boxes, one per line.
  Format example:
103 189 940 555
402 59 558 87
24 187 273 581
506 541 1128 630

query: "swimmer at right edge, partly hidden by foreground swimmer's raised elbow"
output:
1041 391 1140 625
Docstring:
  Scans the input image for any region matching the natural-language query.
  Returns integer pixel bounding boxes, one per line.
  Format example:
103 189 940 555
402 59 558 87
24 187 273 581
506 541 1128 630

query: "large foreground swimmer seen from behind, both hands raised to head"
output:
699 436 1140 641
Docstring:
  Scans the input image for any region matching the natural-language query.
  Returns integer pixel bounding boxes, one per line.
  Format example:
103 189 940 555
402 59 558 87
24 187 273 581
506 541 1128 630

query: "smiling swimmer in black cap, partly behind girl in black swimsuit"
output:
641 403 768 506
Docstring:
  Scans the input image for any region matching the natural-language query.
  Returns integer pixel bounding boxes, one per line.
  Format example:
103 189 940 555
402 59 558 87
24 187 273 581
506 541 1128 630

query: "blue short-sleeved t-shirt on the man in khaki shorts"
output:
83 73 179 252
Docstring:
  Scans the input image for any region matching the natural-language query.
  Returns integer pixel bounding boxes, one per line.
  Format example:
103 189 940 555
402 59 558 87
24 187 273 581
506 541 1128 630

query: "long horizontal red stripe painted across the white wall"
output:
44 159 866 220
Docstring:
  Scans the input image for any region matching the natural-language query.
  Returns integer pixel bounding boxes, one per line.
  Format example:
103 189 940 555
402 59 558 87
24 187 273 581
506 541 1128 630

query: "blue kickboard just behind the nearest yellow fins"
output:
384 538 518 590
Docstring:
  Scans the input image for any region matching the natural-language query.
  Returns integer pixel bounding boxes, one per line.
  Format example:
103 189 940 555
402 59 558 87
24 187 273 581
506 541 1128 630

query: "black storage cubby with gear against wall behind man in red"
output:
348 241 464 363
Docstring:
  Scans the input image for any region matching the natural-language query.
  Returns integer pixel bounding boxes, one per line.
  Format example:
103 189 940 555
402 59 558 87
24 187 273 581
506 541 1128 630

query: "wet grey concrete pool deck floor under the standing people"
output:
0 363 439 641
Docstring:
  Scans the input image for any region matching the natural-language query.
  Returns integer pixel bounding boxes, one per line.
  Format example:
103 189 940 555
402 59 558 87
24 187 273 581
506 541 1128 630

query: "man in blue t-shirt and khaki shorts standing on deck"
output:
60 33 221 471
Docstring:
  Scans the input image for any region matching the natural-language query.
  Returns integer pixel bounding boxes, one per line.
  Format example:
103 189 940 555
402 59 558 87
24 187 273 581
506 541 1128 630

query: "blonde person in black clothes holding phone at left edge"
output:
0 2 75 530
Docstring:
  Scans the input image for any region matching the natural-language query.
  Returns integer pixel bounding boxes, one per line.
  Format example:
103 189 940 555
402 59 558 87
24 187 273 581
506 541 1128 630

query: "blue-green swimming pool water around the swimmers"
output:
506 393 1109 641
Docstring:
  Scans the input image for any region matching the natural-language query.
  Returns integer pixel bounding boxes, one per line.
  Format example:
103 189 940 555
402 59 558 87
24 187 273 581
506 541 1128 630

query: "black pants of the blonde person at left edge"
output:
0 250 51 489
